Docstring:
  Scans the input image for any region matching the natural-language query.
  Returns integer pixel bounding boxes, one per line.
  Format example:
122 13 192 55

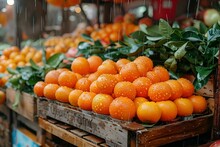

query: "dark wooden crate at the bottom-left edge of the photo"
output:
0 105 11 147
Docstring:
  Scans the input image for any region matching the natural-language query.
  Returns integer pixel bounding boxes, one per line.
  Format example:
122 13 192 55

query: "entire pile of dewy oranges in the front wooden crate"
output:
34 56 207 123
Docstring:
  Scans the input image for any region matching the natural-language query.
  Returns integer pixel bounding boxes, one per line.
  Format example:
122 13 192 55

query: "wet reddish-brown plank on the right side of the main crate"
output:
136 114 213 146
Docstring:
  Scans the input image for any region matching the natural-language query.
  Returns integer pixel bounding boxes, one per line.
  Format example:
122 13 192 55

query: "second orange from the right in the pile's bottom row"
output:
174 98 193 116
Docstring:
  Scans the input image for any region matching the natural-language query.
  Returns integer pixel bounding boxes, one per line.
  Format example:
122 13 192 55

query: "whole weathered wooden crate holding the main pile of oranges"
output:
37 98 212 147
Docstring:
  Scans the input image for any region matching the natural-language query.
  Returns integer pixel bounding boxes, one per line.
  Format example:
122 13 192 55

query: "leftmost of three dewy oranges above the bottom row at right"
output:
148 82 172 102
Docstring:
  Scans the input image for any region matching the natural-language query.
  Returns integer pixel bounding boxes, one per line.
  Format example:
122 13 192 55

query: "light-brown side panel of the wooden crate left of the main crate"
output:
6 88 37 121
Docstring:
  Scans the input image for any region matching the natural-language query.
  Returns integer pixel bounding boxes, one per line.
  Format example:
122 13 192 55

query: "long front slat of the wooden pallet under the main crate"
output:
39 118 101 147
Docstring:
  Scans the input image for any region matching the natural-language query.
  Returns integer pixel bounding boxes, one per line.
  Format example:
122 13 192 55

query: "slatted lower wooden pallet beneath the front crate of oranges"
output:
38 118 105 147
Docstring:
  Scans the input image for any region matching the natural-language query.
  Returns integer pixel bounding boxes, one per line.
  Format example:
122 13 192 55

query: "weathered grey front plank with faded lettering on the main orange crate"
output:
37 98 129 146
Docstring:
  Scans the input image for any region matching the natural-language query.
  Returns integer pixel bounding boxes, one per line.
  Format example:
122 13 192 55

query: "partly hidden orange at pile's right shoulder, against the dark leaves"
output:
153 66 170 82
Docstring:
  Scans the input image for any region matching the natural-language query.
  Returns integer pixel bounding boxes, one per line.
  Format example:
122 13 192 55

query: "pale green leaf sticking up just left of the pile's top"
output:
47 53 65 68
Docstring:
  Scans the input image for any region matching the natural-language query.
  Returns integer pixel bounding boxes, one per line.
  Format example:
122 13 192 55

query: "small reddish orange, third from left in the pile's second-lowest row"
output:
75 78 92 91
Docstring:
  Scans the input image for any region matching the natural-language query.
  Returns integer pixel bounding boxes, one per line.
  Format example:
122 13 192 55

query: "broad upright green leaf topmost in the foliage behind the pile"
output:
159 19 173 38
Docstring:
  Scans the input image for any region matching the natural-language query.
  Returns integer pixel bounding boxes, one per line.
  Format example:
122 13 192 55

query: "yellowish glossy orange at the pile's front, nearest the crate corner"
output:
137 102 161 123
